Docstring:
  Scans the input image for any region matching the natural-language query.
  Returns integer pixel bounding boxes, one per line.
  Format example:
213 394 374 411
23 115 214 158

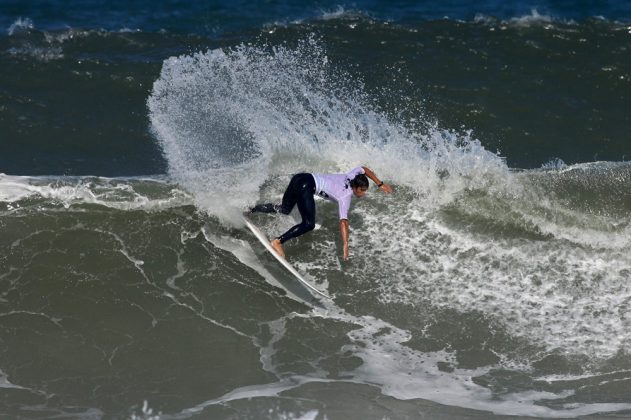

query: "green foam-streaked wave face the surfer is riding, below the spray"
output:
0 167 631 418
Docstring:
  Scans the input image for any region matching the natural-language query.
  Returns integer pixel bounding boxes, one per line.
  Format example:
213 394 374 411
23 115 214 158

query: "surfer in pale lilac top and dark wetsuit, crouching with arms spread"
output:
251 166 392 261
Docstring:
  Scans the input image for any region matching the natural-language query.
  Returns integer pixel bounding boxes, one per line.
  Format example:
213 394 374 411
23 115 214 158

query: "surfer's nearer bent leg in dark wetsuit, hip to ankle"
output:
278 174 315 244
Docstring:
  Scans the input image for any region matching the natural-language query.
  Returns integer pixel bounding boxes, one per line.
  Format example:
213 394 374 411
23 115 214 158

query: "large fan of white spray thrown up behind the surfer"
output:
147 38 508 225
